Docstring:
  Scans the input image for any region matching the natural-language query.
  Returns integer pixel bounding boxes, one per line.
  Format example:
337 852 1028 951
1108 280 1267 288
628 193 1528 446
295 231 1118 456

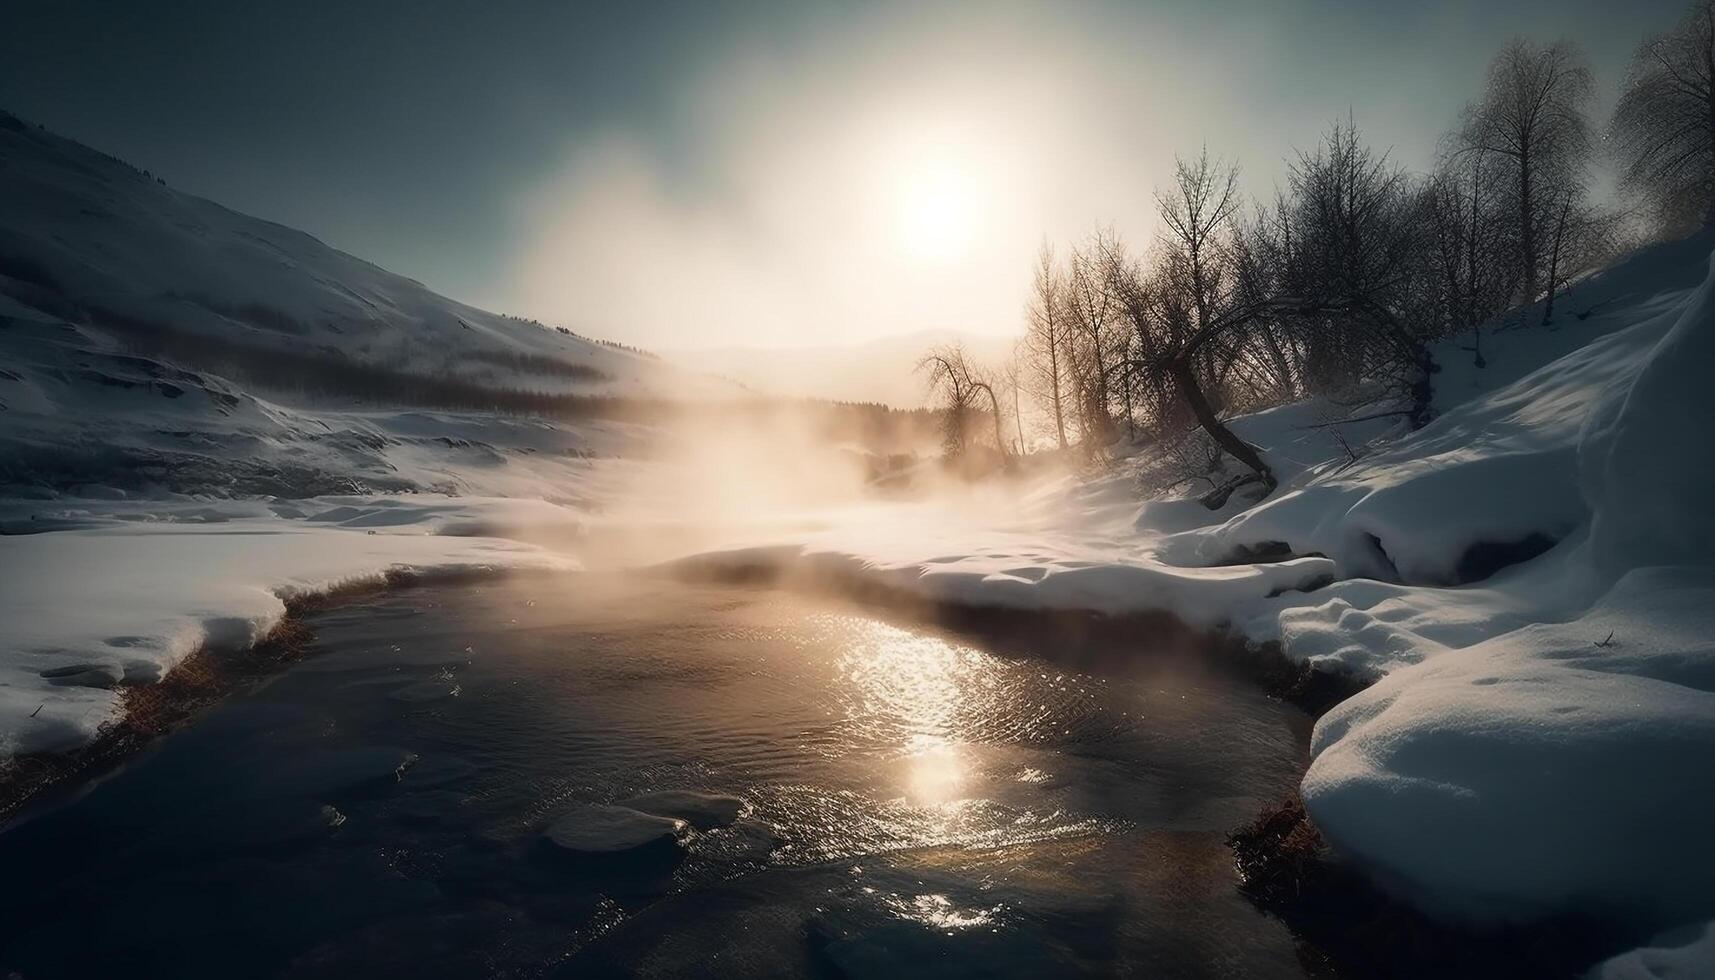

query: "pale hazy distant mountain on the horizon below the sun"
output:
662 331 1015 408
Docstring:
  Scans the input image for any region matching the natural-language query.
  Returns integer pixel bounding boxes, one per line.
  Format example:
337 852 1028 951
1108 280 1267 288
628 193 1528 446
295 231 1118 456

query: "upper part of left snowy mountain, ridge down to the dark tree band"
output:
0 113 657 393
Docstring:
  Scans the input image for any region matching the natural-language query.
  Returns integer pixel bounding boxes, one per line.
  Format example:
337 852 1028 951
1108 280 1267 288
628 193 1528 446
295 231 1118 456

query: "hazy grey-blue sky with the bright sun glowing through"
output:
0 0 1684 350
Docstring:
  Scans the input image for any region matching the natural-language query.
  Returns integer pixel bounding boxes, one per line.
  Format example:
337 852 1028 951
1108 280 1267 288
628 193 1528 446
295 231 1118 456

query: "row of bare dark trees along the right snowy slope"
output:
923 0 1715 506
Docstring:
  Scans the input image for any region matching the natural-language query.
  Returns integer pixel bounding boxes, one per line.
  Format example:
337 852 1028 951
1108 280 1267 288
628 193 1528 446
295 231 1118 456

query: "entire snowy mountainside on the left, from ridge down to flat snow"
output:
0 113 736 499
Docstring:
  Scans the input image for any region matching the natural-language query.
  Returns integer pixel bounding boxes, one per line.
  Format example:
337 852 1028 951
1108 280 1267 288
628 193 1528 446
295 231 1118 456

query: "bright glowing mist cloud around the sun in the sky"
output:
500 5 1282 347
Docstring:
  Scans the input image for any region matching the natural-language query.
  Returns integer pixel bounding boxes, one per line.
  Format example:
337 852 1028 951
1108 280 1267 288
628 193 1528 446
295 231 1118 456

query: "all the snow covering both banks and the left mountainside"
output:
0 117 1715 977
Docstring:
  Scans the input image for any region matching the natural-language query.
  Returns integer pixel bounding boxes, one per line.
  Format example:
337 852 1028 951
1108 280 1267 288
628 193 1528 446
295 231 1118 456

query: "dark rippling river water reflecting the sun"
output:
0 575 1309 978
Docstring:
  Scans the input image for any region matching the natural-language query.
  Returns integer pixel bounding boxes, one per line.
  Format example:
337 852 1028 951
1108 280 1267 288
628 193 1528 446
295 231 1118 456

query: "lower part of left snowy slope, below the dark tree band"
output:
0 295 638 501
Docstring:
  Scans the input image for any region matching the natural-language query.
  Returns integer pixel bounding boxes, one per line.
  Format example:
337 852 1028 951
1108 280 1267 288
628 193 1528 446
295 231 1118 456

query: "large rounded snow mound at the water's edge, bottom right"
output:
1303 568 1715 922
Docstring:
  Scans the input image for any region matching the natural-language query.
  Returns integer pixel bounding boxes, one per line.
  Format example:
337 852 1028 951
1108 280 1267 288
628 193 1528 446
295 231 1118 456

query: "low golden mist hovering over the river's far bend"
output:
555 400 1067 568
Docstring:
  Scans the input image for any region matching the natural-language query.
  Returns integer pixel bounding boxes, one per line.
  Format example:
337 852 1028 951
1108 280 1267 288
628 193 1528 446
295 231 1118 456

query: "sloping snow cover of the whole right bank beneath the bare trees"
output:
668 235 1715 927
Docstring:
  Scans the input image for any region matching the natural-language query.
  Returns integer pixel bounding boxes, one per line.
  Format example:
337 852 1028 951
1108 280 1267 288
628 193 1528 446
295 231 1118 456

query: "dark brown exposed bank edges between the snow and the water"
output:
0 560 1617 978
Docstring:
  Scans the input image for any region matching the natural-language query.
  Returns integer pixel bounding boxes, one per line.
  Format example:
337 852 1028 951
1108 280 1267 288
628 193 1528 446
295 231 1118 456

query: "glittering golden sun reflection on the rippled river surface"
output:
761 611 1108 863
